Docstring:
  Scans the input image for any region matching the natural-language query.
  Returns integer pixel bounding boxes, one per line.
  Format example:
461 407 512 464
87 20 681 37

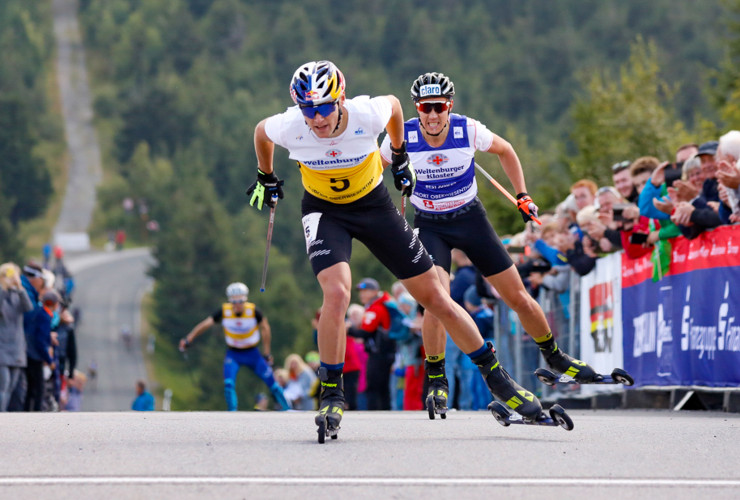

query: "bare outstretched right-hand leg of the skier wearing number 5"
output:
403 269 483 354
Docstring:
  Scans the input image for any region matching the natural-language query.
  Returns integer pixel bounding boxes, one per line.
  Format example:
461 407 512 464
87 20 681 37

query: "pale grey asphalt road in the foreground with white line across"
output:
0 410 740 500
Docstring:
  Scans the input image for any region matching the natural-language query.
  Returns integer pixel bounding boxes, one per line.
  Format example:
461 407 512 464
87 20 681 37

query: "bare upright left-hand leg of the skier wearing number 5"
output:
317 262 352 365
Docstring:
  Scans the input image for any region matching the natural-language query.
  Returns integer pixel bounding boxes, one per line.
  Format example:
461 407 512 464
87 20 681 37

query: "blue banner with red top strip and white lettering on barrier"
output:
622 226 740 387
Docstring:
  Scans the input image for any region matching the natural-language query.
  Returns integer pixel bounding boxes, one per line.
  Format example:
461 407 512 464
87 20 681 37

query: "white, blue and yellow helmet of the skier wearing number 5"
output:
290 61 344 106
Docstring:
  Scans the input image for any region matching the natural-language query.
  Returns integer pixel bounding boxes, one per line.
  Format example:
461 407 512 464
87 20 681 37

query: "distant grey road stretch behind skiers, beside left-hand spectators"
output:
65 248 152 411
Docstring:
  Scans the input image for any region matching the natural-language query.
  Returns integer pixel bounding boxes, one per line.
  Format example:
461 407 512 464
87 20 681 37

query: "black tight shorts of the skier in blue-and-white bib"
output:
414 198 514 277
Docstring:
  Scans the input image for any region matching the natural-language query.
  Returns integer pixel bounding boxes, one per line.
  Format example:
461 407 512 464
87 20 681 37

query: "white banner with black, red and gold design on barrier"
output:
580 252 623 394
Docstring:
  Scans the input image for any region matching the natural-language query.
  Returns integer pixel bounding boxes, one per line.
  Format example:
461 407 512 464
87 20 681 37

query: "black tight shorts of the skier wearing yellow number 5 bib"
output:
301 184 432 279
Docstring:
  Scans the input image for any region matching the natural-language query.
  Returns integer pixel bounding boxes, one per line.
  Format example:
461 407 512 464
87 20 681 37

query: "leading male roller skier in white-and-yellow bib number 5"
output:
247 61 542 442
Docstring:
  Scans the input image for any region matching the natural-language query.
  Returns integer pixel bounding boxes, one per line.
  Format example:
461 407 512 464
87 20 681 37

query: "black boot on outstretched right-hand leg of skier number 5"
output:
473 342 542 420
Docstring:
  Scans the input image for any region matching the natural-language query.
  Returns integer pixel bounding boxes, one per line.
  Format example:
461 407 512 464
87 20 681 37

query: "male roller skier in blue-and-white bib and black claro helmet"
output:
380 69 596 411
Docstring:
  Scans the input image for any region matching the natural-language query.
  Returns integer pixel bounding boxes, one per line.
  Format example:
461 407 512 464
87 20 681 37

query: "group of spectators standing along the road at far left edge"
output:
0 247 86 412
